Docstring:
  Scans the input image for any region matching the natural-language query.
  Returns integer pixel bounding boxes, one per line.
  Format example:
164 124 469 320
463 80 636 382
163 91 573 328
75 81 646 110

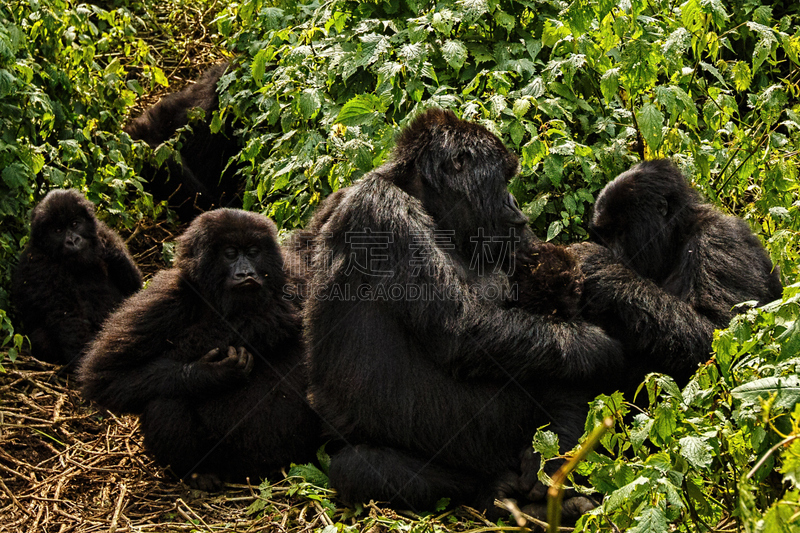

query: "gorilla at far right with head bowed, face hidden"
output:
571 159 782 392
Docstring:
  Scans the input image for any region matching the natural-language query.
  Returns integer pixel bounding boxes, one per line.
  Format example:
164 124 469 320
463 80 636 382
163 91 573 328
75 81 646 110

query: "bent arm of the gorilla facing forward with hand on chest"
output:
78 270 253 414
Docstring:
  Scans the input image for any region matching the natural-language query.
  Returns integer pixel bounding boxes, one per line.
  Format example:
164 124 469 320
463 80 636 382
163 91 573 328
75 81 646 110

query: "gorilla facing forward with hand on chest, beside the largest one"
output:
79 209 319 489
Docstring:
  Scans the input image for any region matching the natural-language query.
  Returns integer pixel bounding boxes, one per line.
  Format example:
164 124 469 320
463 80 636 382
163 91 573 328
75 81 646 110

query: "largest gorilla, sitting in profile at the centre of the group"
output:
306 109 620 512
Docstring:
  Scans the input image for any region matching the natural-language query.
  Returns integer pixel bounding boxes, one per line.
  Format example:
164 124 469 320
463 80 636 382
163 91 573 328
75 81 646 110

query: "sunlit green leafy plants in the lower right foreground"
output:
533 284 800 532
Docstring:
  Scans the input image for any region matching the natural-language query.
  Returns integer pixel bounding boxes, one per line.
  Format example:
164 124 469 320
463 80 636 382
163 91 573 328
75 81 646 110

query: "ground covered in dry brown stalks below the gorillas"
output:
0 354 527 533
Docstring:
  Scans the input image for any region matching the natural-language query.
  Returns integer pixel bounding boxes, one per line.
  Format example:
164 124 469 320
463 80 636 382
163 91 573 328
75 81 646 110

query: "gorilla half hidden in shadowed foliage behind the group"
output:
125 63 241 221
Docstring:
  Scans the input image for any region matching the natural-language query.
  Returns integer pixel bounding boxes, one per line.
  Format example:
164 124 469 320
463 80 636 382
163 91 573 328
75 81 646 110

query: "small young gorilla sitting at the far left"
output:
11 190 142 369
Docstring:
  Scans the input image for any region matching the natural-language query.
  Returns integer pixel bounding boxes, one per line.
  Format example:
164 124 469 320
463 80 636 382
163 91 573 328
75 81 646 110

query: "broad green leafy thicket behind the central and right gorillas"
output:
216 0 800 279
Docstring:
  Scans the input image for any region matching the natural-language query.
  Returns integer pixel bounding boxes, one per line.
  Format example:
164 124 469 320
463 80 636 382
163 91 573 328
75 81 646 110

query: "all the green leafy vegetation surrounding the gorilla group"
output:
0 0 800 532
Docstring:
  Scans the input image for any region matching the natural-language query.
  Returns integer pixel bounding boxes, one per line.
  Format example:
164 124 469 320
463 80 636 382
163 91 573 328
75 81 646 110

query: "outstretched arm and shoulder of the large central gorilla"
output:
318 178 621 379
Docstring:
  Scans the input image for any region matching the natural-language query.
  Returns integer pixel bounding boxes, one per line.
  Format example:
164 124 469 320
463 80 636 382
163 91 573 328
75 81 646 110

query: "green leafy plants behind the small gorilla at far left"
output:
0 0 163 359
